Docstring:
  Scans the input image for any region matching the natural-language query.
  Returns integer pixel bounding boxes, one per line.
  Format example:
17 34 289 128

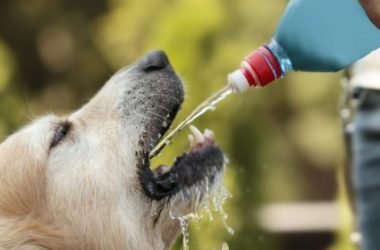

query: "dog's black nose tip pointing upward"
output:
139 50 170 72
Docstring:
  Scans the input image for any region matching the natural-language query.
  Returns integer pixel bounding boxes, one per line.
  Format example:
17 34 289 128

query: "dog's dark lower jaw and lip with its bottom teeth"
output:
143 126 224 200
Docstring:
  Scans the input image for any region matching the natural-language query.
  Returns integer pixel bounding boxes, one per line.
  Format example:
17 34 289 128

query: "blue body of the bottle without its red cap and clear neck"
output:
274 0 380 72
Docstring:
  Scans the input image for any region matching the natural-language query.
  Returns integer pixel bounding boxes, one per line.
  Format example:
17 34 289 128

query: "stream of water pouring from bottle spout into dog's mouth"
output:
149 86 233 159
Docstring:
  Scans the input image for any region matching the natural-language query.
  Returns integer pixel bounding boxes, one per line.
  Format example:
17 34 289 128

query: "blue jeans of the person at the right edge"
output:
352 89 380 250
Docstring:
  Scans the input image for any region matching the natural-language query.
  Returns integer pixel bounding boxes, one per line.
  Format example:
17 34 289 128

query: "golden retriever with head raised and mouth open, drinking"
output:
0 51 224 250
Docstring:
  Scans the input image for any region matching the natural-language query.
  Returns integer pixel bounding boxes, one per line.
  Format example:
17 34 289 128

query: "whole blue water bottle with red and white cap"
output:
228 0 380 93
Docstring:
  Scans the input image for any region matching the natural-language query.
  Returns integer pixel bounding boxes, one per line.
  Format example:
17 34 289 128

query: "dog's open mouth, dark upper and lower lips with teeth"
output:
139 70 224 203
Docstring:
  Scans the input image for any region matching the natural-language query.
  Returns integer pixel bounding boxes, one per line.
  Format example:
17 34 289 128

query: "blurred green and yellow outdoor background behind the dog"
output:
0 0 352 250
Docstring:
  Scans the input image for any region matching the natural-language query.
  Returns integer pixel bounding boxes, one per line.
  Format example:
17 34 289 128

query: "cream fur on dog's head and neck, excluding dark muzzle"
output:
0 67 184 250
